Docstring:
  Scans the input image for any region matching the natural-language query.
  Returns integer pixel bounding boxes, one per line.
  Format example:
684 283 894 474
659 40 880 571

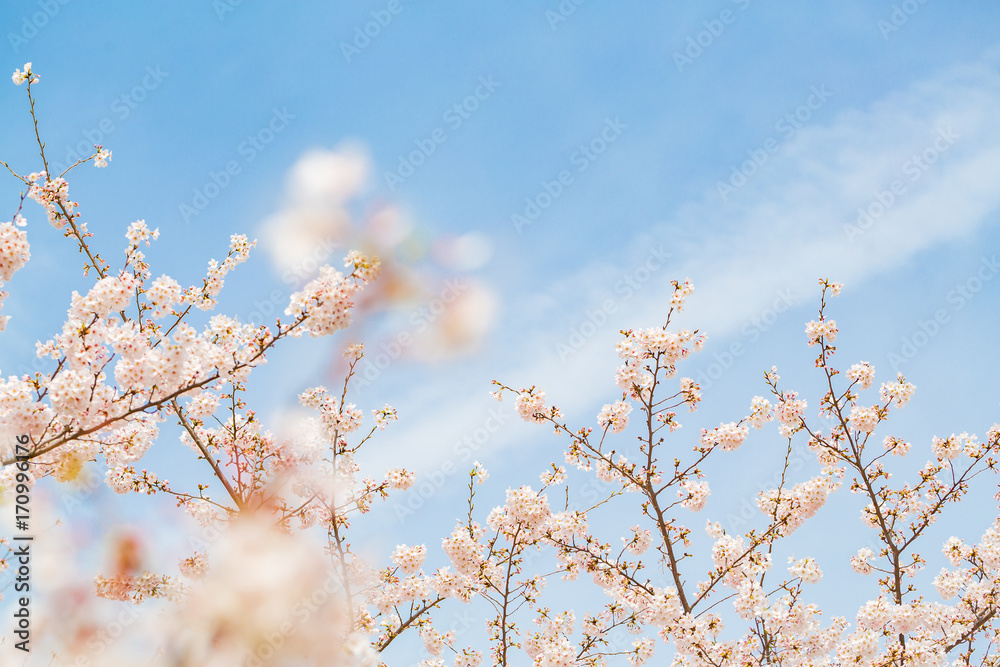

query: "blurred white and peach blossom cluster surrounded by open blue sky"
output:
261 144 497 374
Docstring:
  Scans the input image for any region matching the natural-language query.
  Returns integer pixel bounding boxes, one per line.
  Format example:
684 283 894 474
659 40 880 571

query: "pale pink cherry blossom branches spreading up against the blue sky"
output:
0 70 1000 667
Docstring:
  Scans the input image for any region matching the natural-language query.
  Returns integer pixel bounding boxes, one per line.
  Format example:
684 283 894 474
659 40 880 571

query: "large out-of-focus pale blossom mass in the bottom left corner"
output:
0 500 364 667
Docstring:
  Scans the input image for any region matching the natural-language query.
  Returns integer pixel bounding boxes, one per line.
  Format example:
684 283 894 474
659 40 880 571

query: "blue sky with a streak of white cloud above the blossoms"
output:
0 0 1000 664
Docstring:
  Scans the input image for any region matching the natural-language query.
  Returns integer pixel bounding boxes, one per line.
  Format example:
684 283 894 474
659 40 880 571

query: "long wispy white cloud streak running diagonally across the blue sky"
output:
360 56 1000 469
